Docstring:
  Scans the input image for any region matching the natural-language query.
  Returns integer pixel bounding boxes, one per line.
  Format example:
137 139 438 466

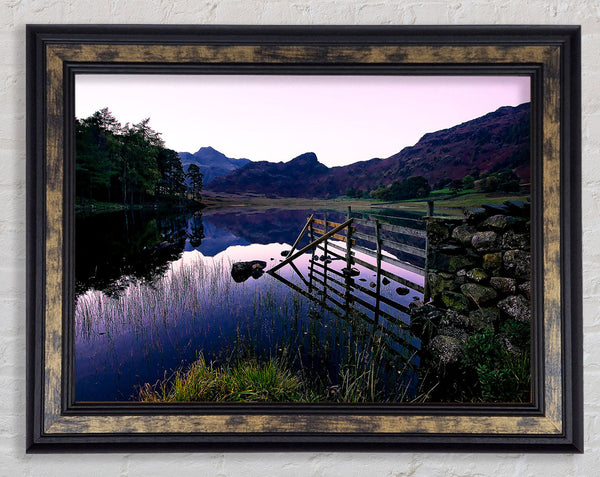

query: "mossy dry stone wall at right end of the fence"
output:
411 201 531 400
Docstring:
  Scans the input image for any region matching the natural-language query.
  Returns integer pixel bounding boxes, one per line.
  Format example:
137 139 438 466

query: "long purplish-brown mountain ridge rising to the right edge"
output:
205 103 530 197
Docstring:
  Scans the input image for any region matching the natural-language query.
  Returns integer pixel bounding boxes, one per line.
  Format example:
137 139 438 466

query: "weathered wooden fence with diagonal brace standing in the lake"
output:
268 208 427 358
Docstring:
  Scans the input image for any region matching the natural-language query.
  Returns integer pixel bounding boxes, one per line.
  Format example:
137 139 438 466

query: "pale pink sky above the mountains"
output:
75 75 530 167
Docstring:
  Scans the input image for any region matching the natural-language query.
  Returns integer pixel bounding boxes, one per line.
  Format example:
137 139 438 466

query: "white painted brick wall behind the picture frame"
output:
0 0 600 477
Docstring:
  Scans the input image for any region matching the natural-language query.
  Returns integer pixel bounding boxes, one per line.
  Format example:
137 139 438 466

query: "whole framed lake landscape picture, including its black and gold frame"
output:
27 25 583 452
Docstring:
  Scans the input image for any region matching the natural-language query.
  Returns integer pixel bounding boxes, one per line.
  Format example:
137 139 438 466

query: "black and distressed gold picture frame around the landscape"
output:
27 25 583 452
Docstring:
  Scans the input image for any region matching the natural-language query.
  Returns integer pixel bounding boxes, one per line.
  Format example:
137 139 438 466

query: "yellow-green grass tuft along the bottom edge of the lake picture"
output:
138 330 420 403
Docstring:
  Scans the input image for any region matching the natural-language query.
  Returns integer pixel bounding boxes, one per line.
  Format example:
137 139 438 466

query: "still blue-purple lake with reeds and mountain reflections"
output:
74 207 424 402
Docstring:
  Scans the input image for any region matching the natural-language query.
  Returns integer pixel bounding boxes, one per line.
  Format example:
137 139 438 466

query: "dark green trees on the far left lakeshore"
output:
75 108 202 206
